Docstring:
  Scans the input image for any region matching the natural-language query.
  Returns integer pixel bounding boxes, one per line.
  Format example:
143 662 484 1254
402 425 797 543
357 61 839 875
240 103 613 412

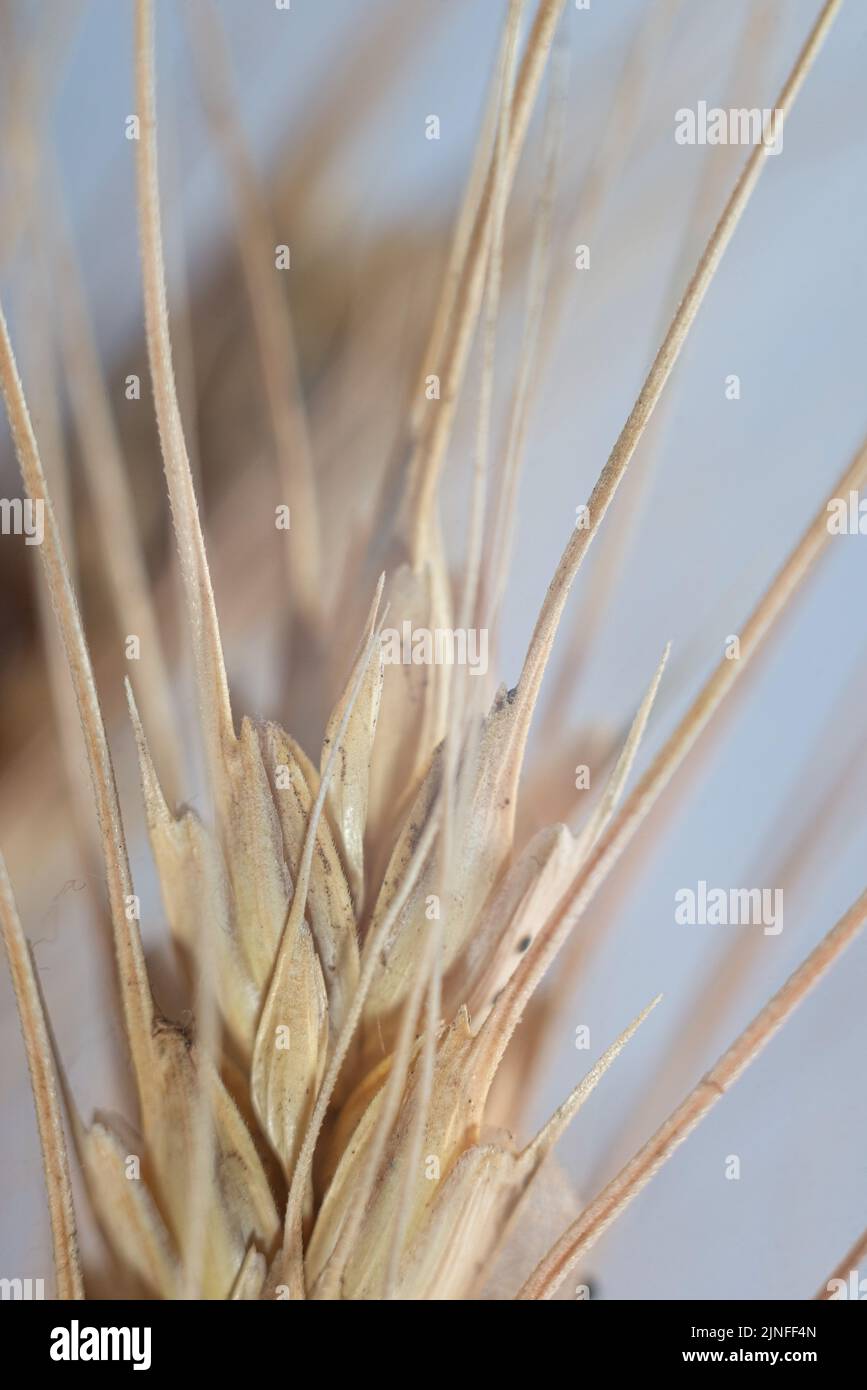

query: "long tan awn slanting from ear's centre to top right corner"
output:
518 0 842 739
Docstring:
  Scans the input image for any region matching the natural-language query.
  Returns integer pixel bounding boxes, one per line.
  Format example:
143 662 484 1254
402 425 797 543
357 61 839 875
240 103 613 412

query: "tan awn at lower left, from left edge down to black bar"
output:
0 855 85 1300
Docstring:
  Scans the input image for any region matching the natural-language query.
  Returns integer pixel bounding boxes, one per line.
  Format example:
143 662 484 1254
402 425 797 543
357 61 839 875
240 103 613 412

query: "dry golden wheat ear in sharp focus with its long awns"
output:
0 0 867 1300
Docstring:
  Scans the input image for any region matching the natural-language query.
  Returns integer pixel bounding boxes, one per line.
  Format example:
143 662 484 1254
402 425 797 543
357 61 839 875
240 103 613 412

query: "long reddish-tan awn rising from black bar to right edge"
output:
518 891 867 1300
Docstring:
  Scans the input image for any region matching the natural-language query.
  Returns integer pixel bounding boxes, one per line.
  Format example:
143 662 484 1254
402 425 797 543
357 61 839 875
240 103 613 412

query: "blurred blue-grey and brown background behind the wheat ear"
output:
0 0 867 1298
